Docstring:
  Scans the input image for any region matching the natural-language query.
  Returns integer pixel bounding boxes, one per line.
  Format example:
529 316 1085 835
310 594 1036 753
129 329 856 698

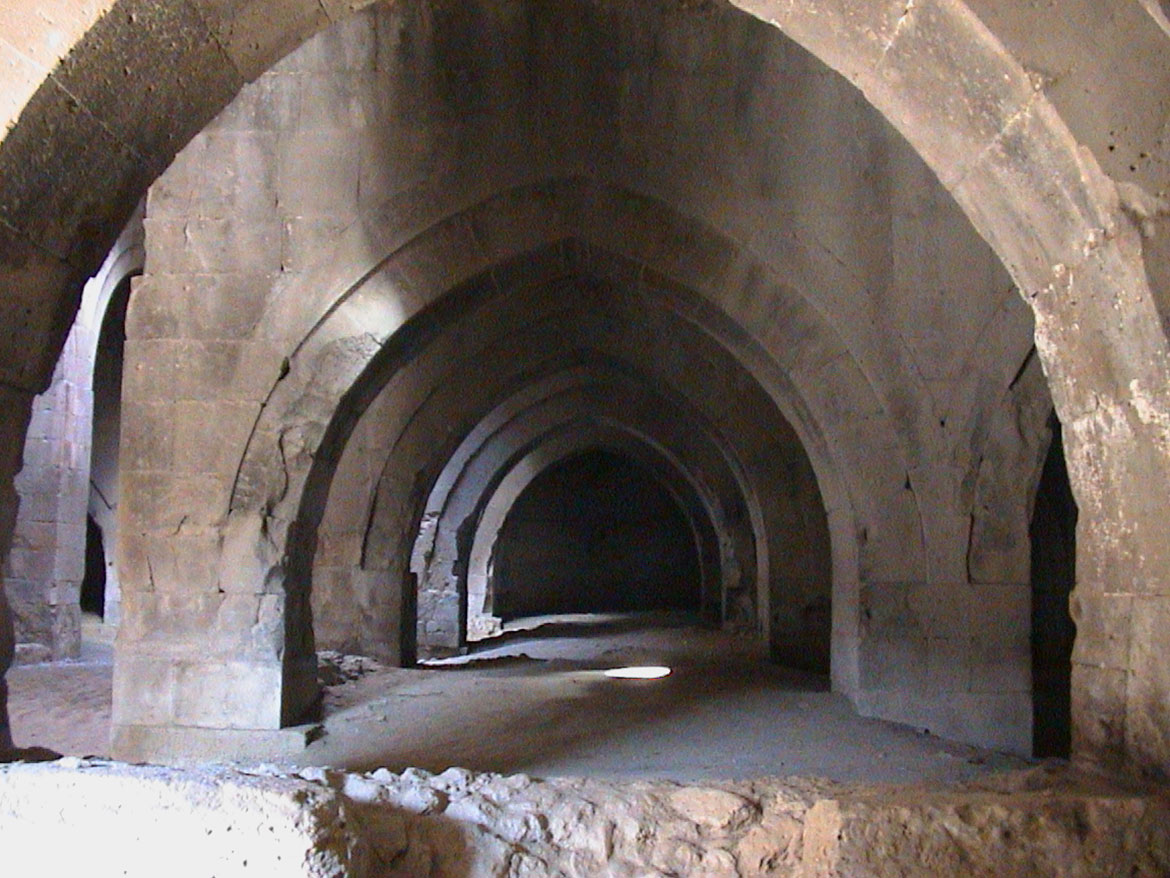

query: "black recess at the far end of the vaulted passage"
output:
489 451 701 619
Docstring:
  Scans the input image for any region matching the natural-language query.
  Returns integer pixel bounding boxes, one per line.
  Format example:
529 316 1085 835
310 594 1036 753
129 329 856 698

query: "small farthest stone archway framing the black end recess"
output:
397 375 767 660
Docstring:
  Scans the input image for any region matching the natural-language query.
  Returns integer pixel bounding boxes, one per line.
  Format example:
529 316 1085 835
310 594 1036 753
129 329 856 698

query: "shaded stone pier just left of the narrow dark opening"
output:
853 454 1032 755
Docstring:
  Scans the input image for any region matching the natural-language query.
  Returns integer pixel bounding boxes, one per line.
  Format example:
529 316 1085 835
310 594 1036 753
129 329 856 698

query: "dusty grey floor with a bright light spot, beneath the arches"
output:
9 617 1027 784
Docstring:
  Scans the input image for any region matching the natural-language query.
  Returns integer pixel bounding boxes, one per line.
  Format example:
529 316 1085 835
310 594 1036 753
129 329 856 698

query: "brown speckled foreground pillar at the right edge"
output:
1032 227 1170 778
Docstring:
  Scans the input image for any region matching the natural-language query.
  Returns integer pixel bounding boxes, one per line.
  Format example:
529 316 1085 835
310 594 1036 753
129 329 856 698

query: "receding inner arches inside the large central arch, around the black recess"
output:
314 242 832 671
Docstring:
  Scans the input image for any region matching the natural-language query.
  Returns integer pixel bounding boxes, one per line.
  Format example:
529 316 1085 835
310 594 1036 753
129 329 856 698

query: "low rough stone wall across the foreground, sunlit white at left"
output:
0 759 1170 878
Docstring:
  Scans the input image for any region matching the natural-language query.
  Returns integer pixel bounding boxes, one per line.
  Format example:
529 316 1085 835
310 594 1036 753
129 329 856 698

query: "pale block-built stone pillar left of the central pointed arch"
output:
112 224 316 761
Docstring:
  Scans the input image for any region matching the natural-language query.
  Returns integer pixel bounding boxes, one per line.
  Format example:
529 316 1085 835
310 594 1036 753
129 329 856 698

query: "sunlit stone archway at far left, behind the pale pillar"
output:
2 211 145 661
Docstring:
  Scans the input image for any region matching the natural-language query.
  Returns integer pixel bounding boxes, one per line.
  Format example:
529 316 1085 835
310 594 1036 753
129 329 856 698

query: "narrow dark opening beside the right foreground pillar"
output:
1031 417 1076 757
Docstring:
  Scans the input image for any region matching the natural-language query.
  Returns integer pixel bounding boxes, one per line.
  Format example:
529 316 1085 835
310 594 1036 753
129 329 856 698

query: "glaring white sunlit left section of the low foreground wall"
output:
0 759 369 878
